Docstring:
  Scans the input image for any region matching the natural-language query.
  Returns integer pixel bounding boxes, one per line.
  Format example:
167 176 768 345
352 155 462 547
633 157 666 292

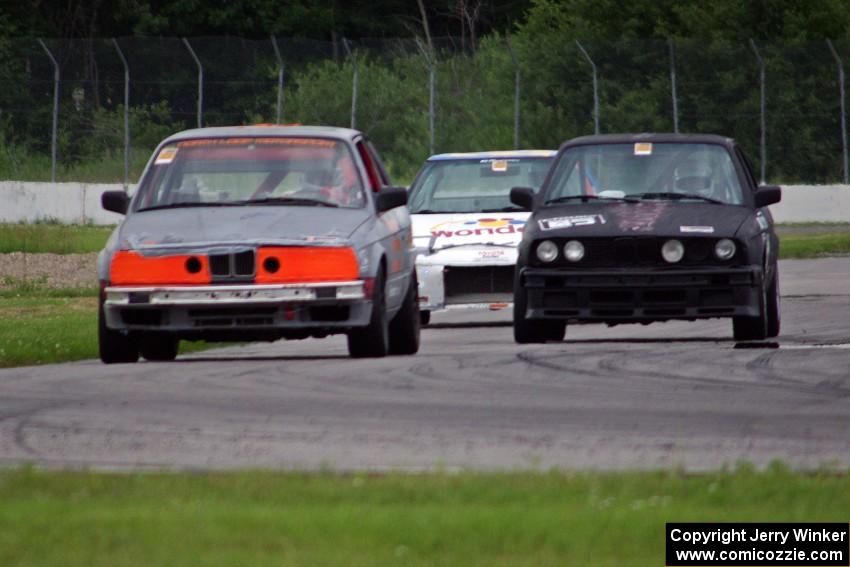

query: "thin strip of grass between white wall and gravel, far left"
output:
0 223 114 254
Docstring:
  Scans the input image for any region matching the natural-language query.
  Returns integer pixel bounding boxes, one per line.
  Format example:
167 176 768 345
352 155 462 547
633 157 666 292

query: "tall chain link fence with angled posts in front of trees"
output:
0 34 850 183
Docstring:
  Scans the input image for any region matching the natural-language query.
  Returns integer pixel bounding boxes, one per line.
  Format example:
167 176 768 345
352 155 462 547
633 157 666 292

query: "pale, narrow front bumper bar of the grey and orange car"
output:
104 280 366 307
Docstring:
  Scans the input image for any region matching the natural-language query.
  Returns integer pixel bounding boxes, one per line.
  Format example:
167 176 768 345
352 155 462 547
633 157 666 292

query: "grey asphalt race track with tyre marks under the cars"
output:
0 257 850 470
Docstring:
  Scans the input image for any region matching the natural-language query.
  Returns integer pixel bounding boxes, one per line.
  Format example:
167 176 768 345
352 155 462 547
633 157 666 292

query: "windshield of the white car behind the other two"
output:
409 157 551 213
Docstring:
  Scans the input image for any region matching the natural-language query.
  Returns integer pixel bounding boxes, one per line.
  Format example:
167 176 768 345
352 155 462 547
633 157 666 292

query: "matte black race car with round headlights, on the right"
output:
511 134 782 343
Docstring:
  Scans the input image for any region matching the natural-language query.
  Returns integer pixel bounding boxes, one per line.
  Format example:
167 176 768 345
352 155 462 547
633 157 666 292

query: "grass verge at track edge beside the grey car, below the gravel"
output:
0 289 214 368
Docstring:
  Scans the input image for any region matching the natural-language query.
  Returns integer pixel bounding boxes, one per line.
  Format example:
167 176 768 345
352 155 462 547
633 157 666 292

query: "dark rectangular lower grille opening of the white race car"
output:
443 266 514 303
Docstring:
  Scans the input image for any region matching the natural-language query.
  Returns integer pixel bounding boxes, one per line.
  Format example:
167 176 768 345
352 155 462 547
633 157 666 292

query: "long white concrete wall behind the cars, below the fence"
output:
0 181 850 224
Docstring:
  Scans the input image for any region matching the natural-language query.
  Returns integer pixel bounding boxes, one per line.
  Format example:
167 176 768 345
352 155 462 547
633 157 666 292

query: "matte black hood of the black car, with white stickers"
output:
526 201 753 237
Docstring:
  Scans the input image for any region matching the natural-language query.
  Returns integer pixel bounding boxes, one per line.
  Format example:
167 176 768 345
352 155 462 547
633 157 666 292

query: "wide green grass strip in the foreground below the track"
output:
0 466 850 567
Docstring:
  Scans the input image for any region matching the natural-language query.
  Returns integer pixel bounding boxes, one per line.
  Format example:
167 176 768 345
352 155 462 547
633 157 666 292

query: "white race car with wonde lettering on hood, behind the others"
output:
409 150 556 325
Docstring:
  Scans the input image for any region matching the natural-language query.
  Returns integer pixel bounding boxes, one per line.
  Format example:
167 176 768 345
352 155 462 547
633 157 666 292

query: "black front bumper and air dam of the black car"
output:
520 266 764 322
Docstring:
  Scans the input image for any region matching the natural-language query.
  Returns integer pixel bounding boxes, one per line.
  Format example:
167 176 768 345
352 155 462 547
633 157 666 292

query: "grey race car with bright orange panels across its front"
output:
98 126 419 363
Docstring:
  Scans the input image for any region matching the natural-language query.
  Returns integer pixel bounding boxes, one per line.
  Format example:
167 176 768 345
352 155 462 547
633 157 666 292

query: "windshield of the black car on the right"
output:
544 142 743 205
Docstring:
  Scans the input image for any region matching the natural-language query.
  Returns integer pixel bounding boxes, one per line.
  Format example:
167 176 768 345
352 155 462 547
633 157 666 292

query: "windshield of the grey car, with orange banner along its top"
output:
135 137 366 211
